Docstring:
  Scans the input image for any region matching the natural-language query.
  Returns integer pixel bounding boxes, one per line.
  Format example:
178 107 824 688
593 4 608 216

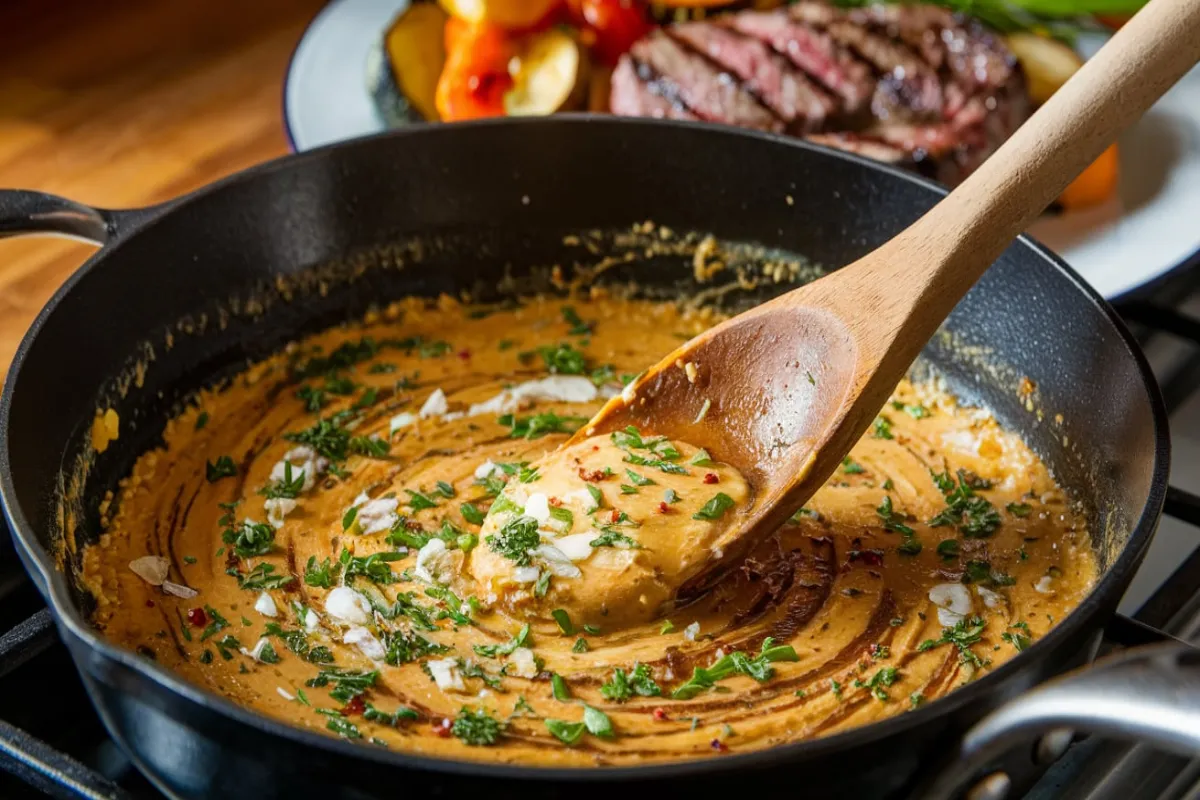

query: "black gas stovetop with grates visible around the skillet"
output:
0 271 1200 800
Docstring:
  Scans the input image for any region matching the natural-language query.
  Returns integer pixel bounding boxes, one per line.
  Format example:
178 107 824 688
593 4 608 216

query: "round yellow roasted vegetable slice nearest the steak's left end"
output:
504 29 588 116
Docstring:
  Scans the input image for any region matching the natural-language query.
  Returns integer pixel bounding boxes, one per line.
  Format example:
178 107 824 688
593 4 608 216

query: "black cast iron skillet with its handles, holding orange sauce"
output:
0 118 1200 798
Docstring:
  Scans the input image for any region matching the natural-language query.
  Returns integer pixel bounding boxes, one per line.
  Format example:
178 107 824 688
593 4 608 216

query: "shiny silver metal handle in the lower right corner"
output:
913 640 1200 800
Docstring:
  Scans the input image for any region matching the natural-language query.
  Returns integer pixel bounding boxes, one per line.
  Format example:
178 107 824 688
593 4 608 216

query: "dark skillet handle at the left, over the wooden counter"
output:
0 190 152 245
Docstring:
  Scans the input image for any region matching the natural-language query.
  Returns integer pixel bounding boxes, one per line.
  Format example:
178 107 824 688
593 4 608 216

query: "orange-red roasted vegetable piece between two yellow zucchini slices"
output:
436 19 516 122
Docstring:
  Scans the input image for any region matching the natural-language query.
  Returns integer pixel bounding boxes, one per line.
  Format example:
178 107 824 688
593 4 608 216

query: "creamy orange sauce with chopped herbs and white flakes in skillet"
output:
84 297 1097 765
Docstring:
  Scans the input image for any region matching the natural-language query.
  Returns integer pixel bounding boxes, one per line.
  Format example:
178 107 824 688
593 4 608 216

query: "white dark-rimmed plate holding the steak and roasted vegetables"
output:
283 0 1200 300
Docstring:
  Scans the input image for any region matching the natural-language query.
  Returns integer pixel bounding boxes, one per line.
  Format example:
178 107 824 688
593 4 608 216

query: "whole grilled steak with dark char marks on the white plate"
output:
611 0 1030 184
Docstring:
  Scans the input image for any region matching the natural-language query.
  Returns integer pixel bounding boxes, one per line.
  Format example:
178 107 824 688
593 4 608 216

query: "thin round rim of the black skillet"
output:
0 114 1170 783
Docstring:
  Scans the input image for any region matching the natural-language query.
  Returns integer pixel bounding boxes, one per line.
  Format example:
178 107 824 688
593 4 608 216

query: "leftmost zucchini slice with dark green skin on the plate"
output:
367 2 448 125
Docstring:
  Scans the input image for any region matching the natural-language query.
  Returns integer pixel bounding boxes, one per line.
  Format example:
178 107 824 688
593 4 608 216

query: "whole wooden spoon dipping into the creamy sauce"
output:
572 0 1200 597
